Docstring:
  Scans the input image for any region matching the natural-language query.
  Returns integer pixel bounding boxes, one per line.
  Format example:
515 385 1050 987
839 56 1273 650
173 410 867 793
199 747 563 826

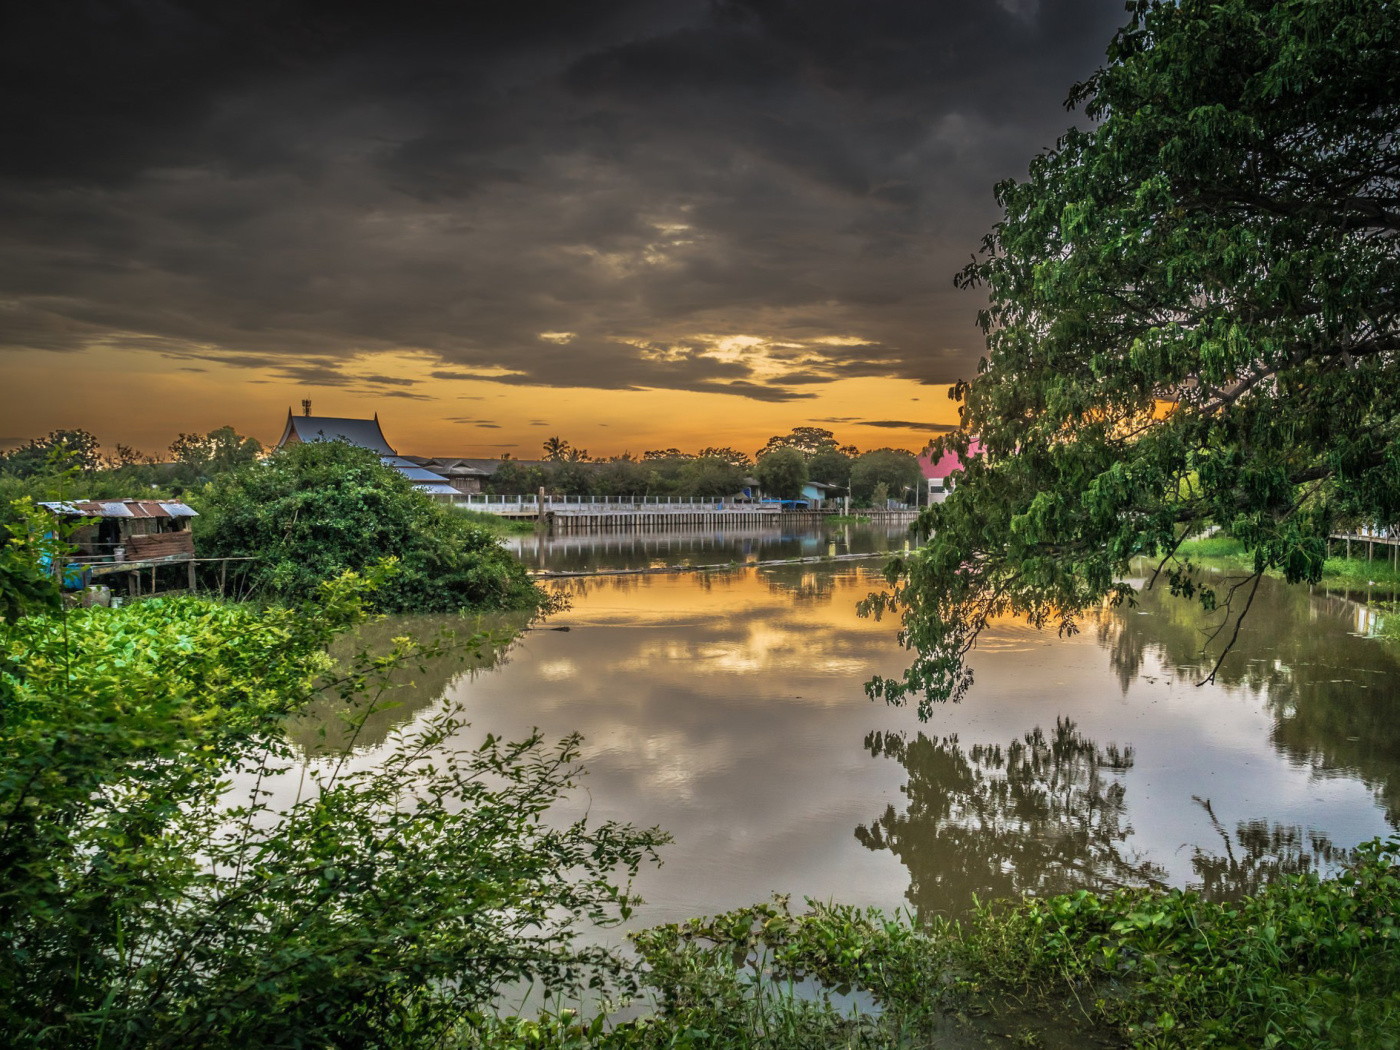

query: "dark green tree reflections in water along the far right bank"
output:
1099 578 1400 826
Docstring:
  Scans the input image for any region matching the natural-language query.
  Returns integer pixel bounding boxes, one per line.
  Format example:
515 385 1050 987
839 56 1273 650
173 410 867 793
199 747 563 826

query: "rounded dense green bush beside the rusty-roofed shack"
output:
195 441 545 612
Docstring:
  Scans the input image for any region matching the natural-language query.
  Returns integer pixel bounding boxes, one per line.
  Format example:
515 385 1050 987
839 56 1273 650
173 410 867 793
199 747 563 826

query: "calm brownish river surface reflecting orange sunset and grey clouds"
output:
287 528 1400 925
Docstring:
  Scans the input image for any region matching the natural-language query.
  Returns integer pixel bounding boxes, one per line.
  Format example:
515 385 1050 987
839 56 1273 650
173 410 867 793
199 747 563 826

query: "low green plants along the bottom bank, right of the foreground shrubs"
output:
462 840 1400 1050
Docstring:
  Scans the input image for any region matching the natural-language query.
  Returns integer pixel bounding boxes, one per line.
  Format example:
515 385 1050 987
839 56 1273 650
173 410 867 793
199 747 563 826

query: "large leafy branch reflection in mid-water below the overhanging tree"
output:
855 718 1162 911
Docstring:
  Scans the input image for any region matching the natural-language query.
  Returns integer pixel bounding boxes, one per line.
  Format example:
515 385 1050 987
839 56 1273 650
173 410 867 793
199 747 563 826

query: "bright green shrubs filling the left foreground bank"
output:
0 573 662 1047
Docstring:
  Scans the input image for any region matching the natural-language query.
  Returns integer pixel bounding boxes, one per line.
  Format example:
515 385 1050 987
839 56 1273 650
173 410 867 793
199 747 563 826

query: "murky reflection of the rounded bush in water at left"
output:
287 613 531 753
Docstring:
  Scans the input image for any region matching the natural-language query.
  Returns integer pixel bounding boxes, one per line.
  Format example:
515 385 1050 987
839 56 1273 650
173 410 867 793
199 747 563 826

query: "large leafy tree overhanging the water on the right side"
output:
871 0 1400 703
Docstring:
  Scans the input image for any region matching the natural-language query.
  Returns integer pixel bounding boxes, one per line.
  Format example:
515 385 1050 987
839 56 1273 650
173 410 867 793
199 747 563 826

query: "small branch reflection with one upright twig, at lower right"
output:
1191 798 1352 900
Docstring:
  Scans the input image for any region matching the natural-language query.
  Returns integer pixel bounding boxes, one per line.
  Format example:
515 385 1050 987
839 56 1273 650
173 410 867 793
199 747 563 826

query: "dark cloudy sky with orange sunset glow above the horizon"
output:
0 0 1126 456
